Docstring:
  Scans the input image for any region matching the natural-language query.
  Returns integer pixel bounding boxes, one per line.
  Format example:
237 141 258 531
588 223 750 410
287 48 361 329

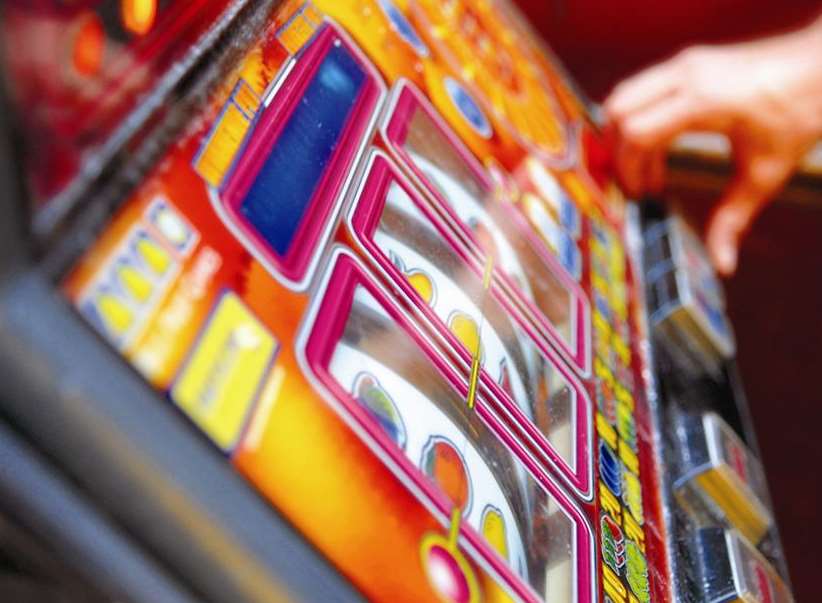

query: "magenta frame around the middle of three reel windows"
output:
350 153 593 498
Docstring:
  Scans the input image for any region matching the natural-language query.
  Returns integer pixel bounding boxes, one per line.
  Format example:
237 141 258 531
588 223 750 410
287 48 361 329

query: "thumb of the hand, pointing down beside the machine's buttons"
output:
706 158 791 276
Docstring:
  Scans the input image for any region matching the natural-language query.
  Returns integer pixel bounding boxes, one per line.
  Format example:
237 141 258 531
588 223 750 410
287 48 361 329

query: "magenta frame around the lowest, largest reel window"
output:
305 254 594 603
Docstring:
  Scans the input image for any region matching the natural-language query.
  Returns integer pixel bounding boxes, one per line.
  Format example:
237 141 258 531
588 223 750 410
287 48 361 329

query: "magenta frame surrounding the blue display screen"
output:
214 24 381 281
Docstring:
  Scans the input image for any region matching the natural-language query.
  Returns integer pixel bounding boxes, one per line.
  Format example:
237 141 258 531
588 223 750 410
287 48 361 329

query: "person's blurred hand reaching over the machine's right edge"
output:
604 18 822 275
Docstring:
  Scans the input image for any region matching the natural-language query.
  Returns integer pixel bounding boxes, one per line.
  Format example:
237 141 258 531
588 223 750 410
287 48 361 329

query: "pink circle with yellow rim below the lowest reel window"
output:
420 533 480 603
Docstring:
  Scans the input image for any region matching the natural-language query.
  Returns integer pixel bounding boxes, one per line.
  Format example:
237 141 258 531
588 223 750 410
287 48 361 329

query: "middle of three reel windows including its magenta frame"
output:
346 150 593 500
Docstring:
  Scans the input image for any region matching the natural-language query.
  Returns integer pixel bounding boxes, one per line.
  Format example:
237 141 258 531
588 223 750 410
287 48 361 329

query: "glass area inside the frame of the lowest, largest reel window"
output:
328 286 576 603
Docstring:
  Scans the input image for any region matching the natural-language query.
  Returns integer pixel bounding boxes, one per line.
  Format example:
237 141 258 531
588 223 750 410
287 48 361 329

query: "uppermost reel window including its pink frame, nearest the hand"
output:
381 80 591 377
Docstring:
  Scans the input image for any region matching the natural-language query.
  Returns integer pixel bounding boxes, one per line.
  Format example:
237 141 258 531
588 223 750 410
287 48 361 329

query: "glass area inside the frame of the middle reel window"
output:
374 183 577 469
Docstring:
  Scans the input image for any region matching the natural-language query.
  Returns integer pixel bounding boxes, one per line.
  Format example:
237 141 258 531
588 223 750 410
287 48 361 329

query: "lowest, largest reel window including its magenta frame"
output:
298 247 595 603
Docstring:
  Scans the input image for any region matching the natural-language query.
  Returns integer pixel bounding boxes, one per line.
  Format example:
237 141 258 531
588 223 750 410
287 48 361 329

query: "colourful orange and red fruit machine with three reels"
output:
0 0 792 603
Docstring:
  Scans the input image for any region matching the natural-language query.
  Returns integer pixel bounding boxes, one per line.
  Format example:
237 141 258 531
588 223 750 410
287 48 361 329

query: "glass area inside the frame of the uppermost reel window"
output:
404 109 575 348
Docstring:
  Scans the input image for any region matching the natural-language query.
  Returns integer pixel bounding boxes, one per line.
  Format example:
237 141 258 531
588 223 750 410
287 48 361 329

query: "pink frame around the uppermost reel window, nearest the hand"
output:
384 81 591 375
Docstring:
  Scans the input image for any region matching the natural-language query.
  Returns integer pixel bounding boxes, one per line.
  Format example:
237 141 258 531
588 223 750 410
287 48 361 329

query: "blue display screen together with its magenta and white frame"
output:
210 23 385 289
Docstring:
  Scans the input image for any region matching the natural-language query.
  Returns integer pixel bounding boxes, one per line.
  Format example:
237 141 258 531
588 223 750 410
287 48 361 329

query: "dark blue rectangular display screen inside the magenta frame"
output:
240 40 366 256
